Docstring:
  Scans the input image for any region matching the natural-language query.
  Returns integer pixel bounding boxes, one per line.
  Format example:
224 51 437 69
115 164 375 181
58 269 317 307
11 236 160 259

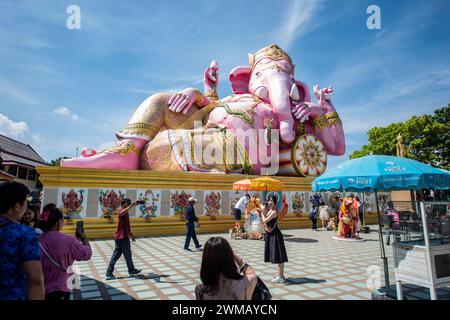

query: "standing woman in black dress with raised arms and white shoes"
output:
262 196 288 283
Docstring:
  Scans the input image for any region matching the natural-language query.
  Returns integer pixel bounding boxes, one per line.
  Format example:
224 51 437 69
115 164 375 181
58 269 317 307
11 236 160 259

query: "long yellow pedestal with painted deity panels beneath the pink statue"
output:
36 166 376 238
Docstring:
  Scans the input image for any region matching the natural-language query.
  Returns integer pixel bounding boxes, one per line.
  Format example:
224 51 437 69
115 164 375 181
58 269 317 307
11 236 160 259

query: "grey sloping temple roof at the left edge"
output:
0 134 47 168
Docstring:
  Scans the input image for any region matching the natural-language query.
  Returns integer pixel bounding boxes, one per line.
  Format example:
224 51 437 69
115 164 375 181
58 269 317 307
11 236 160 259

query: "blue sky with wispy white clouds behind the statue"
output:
0 0 450 170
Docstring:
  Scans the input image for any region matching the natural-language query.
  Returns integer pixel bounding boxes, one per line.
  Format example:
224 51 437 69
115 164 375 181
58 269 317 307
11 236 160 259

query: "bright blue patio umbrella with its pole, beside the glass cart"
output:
312 155 450 294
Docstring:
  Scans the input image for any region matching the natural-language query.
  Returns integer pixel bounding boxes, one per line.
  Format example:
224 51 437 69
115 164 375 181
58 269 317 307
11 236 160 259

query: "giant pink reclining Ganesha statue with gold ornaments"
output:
61 45 345 177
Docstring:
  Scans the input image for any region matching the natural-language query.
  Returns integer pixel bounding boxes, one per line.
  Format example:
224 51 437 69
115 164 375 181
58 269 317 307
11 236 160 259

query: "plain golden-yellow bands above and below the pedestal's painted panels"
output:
36 166 377 239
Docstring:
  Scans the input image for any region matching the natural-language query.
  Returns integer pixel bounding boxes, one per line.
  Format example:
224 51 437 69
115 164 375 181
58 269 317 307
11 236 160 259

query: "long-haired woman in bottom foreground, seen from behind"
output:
195 237 258 300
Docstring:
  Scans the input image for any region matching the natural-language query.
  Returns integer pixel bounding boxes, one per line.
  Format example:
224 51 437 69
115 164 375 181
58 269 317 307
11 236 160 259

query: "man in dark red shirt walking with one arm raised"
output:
106 198 142 280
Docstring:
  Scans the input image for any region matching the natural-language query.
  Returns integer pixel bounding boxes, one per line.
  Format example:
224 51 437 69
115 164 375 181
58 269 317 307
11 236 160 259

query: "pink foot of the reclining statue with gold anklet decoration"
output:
61 138 147 170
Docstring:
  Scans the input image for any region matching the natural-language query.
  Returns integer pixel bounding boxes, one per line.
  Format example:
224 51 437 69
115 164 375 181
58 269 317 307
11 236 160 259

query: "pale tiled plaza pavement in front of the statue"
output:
72 229 450 300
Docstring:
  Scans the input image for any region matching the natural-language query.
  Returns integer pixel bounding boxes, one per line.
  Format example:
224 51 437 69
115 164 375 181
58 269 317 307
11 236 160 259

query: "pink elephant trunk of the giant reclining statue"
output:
267 72 295 143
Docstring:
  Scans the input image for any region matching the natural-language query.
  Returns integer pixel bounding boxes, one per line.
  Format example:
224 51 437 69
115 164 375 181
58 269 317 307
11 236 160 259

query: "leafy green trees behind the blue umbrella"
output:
350 104 450 170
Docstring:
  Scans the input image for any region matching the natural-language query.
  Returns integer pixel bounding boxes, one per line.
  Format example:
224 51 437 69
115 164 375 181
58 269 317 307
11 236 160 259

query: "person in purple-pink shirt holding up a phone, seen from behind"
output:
38 206 92 300
